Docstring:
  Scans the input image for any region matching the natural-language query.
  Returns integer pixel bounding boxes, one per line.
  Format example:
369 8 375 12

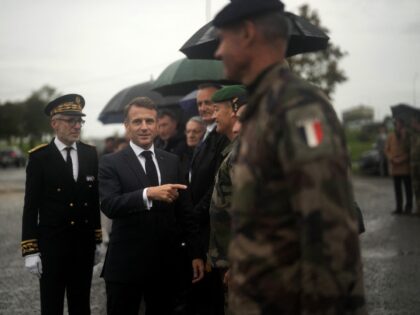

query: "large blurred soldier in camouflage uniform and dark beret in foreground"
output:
213 0 366 315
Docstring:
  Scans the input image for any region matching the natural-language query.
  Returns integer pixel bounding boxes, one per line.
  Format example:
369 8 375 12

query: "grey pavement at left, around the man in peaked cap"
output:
0 168 106 315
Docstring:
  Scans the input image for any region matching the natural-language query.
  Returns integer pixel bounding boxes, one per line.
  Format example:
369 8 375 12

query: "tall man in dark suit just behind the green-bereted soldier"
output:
189 84 230 314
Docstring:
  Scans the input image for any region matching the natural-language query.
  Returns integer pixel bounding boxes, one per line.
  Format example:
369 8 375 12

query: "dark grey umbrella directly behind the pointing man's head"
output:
98 81 181 124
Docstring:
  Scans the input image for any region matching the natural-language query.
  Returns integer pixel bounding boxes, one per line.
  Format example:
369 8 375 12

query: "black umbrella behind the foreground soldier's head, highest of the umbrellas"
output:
180 12 329 59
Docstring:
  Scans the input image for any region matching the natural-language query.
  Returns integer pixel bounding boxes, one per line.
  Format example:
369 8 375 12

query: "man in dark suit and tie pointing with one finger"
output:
99 97 204 315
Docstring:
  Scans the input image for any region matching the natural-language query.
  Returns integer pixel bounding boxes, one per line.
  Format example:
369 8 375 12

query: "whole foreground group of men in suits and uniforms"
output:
22 0 367 315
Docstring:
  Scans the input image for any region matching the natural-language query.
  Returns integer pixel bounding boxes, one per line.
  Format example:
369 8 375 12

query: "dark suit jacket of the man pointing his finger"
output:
99 146 198 283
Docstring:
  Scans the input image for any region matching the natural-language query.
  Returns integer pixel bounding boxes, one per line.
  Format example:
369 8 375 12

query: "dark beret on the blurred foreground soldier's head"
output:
213 0 284 28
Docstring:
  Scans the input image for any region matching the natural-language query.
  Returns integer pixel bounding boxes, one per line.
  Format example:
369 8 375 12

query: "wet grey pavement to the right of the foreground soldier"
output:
354 177 420 315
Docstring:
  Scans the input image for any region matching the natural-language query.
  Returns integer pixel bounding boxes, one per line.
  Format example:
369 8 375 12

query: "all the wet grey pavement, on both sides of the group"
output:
0 169 420 315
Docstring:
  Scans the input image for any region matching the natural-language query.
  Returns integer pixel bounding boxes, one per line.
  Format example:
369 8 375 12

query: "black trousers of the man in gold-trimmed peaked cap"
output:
40 250 94 315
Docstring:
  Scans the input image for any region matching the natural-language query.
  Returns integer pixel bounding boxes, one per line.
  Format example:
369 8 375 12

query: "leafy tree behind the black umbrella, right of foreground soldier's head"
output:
288 4 347 97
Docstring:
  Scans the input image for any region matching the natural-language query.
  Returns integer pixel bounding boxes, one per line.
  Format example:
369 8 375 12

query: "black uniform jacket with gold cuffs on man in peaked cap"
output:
22 142 102 256
